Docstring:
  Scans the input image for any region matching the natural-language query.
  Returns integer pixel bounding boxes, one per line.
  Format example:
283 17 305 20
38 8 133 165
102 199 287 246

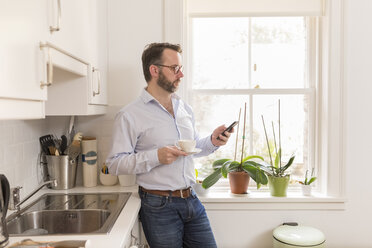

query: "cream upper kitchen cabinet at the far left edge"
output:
0 0 48 119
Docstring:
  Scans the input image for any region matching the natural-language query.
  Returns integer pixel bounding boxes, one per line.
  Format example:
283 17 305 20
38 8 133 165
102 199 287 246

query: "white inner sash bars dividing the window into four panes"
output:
186 15 322 191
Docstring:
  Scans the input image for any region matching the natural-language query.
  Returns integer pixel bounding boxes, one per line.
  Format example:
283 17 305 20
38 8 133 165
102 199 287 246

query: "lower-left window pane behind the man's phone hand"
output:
193 94 249 177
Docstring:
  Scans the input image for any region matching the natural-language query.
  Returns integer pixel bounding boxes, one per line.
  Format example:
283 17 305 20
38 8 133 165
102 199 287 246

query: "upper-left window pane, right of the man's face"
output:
191 18 249 89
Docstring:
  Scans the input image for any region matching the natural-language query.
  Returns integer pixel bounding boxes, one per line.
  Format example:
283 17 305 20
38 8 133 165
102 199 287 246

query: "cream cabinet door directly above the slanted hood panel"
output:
47 0 92 60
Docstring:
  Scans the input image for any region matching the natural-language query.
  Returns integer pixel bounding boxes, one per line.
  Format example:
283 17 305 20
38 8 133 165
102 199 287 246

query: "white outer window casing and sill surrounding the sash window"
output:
163 0 347 210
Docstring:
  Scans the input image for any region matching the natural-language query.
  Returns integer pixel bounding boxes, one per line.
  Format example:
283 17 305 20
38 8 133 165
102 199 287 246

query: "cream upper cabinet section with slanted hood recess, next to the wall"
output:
46 0 107 115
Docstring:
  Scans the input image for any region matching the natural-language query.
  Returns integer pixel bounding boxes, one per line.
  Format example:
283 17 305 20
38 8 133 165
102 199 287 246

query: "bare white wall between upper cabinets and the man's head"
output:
108 0 163 106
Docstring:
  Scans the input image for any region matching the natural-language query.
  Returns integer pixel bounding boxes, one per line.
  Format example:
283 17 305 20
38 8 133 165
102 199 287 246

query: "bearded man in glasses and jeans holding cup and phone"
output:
106 43 230 248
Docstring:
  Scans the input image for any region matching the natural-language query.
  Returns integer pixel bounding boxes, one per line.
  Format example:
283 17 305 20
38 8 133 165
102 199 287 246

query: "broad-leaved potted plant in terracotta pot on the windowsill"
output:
202 104 268 194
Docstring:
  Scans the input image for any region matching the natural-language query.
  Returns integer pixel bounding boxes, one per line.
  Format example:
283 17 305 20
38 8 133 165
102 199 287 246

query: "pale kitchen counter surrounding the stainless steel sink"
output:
8 185 141 248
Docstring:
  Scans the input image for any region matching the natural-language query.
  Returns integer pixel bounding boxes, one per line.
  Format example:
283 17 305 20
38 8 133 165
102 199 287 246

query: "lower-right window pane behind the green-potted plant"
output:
253 95 309 179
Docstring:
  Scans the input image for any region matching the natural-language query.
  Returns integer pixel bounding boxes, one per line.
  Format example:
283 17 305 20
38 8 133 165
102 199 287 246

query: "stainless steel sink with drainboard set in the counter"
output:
7 193 131 236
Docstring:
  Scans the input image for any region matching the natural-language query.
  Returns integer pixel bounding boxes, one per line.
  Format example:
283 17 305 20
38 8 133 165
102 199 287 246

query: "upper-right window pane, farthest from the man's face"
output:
251 17 306 88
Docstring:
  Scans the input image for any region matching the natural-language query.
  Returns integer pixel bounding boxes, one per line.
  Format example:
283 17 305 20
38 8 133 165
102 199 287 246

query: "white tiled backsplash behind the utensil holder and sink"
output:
0 107 120 196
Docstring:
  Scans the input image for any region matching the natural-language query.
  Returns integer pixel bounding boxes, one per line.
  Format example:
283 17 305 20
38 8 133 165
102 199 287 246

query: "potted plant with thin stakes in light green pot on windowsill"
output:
261 100 295 197
